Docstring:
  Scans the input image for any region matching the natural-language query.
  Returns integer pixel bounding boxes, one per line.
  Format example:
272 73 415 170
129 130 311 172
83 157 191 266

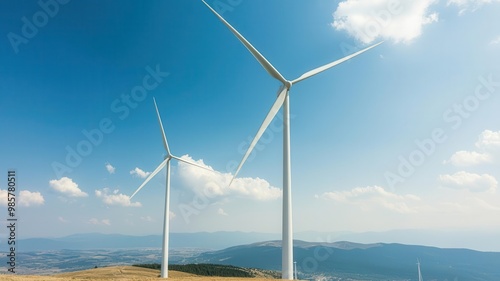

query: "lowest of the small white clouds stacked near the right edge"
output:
438 171 498 192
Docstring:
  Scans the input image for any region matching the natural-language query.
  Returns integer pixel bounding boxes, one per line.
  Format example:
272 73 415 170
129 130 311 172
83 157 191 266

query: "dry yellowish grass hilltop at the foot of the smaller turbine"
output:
0 266 278 281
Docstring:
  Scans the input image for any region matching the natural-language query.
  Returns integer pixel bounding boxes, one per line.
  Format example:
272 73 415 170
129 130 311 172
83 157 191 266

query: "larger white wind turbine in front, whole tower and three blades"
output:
202 0 382 279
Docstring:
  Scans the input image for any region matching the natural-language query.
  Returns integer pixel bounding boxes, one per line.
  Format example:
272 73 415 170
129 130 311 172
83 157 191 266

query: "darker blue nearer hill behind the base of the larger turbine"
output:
186 238 500 281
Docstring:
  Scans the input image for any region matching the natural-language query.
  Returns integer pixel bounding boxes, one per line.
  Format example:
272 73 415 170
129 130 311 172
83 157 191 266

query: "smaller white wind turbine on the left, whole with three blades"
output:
130 98 212 278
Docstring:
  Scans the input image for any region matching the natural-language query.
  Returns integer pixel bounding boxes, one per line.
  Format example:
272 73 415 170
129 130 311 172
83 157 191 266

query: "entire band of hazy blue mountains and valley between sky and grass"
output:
8 232 500 281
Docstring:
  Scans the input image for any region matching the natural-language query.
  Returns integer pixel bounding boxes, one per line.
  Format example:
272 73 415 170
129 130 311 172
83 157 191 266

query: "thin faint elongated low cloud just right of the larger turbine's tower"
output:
321 186 420 213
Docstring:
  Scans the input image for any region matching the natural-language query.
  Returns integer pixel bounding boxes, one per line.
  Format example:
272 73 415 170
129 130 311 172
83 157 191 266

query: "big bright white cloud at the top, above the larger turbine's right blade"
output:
331 0 439 43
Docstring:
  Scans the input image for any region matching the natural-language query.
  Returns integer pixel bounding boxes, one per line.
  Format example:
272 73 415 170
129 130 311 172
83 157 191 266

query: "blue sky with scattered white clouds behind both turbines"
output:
0 0 500 248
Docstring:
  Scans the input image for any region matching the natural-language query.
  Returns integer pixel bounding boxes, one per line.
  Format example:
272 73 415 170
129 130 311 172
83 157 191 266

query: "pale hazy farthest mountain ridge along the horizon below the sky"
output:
16 229 500 252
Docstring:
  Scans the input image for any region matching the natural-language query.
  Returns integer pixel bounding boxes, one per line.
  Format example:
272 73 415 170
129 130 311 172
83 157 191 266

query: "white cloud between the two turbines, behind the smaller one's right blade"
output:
179 155 281 201
